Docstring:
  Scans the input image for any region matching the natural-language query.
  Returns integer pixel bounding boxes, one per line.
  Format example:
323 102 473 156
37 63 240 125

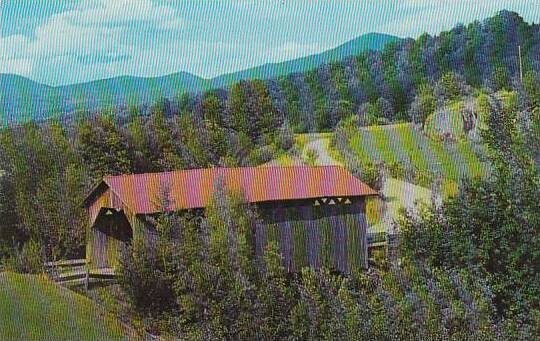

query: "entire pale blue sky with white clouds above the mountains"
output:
0 0 540 85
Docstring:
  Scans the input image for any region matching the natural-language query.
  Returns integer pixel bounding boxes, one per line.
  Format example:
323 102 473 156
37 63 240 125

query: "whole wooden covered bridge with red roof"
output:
84 166 377 273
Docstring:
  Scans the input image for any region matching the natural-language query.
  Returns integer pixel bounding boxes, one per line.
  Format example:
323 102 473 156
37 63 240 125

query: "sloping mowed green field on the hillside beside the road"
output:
350 123 487 194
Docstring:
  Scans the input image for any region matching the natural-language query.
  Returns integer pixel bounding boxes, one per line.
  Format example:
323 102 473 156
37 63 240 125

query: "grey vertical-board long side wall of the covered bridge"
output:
255 213 367 273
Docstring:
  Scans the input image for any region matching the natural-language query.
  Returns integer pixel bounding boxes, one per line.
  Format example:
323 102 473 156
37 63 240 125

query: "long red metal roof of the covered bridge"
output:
89 166 377 214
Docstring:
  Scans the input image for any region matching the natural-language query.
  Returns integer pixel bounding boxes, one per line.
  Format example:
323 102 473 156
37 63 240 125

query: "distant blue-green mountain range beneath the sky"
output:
0 33 400 125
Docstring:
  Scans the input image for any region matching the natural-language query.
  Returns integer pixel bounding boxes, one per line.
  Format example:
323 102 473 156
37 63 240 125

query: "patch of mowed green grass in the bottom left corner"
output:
0 272 127 340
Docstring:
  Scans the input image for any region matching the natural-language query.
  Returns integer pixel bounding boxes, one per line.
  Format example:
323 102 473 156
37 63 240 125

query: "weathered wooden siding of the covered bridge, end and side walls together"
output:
87 191 367 272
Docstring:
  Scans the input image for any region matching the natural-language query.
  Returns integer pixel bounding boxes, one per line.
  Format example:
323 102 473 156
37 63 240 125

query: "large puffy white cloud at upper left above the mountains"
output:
0 0 186 85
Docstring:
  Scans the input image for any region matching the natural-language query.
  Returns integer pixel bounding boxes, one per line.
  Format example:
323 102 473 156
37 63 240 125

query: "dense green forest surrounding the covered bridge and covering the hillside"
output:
0 12 540 340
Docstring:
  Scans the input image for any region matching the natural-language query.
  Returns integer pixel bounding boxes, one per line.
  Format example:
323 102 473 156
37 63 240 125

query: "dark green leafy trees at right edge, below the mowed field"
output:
401 95 540 322
